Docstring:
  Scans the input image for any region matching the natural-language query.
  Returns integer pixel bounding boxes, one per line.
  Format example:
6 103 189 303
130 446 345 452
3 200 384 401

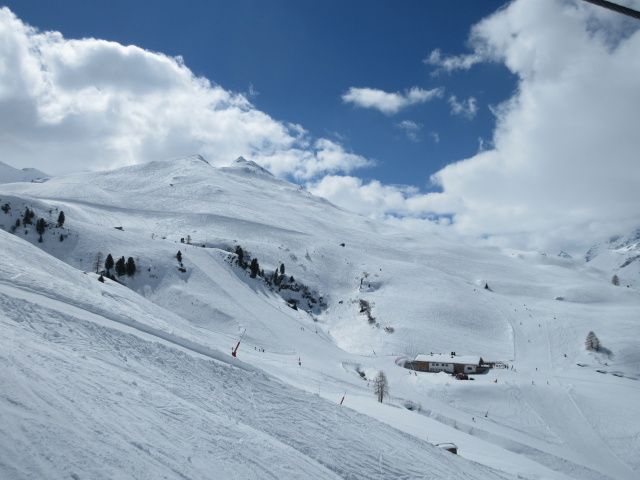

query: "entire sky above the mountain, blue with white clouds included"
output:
0 0 640 255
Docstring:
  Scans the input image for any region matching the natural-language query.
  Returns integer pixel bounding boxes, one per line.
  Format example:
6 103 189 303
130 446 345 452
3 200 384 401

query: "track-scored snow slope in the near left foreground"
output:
0 286 504 478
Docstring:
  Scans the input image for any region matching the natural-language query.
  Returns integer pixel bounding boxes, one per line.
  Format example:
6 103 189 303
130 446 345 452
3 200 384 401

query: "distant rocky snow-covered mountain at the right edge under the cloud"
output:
584 228 640 285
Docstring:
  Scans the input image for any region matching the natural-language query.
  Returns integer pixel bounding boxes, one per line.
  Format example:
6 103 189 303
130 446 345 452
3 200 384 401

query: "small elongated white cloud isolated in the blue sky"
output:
342 87 444 115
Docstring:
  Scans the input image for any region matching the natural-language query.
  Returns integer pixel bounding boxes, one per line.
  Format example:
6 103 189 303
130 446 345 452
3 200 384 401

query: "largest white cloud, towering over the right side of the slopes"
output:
313 0 640 254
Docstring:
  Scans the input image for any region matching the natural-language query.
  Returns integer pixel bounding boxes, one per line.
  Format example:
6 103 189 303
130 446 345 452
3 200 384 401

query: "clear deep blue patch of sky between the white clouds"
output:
5 0 515 189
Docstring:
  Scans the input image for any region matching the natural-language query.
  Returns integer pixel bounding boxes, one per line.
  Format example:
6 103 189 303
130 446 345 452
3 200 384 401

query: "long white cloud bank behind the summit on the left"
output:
0 8 372 179
